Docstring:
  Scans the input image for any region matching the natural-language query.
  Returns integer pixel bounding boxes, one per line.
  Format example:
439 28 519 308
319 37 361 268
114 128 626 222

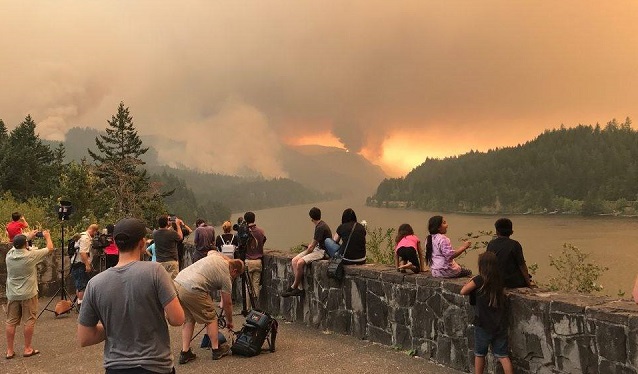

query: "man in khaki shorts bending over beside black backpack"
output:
175 251 244 364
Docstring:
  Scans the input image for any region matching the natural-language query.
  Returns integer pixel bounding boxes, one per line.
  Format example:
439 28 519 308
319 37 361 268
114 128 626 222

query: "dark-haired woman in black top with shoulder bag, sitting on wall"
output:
325 208 366 265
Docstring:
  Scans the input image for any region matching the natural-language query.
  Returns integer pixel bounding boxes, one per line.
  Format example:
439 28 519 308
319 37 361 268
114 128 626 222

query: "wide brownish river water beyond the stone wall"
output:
232 198 638 298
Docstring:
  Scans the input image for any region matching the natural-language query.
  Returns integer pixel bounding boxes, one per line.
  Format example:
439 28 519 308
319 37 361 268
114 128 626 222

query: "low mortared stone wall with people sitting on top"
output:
261 251 638 374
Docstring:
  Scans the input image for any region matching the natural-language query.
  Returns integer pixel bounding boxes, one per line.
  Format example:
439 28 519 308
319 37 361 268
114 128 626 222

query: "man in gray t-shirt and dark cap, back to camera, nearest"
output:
78 218 184 374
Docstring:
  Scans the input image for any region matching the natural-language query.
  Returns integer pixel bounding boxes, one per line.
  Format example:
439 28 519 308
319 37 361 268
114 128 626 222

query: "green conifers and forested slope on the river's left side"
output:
0 103 325 240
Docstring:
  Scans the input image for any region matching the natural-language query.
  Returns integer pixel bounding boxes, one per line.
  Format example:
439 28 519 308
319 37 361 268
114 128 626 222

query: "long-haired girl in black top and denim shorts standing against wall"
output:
461 252 514 374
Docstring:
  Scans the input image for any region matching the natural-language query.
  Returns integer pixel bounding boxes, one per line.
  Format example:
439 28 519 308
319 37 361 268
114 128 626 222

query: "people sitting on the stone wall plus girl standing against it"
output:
282 207 536 374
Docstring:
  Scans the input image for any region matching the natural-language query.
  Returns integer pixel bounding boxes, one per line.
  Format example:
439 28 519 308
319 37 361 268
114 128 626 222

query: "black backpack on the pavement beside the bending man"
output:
230 309 279 357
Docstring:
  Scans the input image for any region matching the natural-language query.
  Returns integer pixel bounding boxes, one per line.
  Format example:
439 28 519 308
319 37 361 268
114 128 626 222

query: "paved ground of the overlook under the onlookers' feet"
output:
0 299 458 374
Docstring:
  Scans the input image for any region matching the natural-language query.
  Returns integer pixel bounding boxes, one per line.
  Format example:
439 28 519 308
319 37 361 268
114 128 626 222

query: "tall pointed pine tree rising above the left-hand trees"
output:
88 102 159 217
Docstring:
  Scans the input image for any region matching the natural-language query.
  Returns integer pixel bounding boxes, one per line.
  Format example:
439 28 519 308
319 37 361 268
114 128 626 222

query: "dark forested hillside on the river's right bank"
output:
368 118 638 215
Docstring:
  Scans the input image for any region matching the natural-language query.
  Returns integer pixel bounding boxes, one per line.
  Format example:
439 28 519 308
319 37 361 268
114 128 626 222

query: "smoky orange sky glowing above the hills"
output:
0 0 638 177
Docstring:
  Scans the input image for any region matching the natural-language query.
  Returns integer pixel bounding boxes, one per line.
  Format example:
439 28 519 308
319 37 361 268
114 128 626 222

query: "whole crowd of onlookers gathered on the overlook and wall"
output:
0 207 560 373
